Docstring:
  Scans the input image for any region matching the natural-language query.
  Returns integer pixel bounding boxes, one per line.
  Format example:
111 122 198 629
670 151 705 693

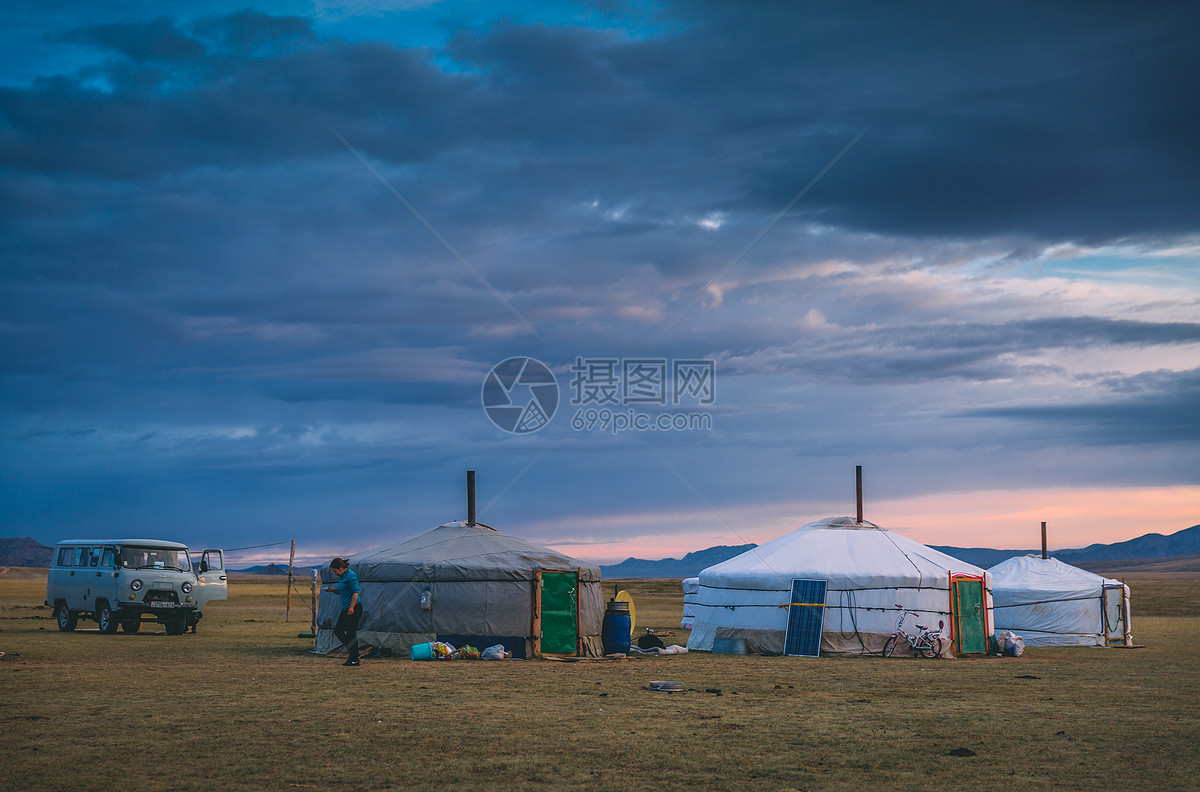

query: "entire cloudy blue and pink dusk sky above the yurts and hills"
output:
0 0 1200 563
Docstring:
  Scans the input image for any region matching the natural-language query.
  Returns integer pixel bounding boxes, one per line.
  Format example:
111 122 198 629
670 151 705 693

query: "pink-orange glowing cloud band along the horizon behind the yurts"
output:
228 486 1200 569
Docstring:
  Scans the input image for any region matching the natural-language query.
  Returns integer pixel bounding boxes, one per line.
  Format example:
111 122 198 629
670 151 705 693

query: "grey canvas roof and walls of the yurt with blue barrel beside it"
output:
317 522 604 658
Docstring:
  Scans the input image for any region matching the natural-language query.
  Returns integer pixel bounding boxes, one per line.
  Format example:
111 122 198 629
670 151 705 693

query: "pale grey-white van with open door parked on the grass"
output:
46 539 228 635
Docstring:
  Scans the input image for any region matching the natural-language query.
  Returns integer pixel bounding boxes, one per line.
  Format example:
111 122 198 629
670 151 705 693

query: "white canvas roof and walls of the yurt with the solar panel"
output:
688 517 991 655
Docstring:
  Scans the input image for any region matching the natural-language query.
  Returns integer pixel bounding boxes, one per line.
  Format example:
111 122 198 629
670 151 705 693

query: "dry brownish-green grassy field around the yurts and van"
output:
0 570 1200 792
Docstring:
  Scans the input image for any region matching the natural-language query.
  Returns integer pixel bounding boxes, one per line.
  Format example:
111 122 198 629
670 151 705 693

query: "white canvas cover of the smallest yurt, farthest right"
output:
988 556 1133 647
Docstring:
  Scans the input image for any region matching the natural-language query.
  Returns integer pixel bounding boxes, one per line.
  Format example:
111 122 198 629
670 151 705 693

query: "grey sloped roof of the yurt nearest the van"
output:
349 522 600 581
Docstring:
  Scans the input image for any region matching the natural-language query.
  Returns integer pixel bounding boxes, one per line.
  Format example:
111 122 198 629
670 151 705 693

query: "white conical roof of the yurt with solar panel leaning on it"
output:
700 517 985 589
